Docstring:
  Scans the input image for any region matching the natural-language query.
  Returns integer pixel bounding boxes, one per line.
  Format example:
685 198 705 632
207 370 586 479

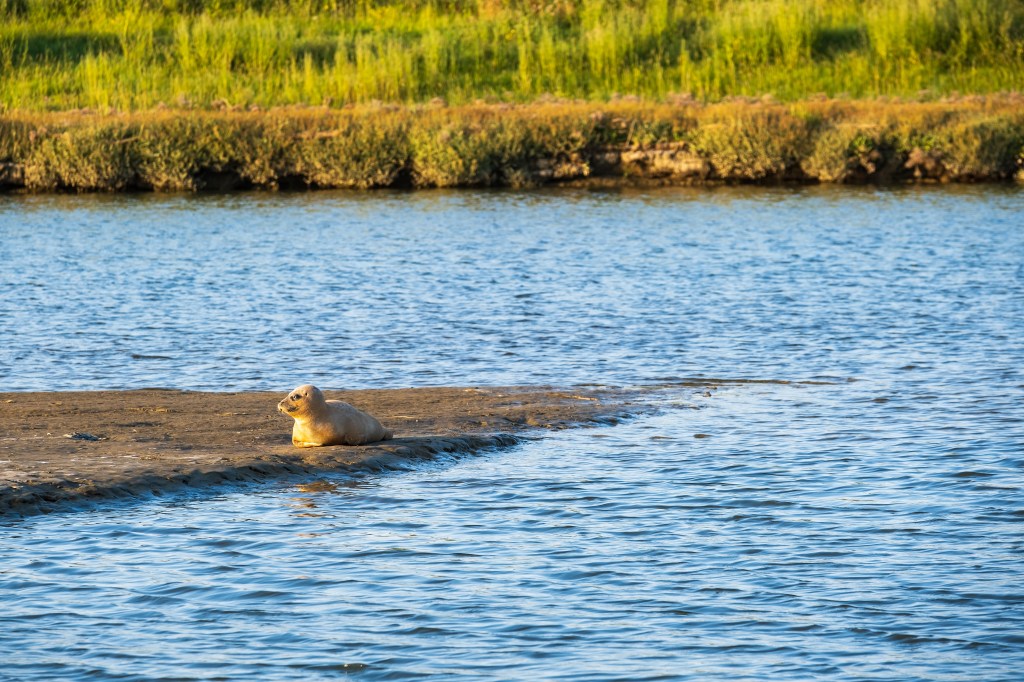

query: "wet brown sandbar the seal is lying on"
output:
0 387 641 516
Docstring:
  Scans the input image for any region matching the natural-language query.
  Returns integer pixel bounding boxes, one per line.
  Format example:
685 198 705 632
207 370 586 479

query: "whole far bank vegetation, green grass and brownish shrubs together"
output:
0 0 1024 190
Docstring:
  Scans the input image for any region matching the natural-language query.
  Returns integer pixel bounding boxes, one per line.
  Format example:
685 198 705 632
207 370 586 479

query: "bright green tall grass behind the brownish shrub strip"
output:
0 0 1024 111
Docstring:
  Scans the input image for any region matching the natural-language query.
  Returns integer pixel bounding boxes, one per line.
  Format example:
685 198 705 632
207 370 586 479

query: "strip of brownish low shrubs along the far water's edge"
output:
0 95 1024 190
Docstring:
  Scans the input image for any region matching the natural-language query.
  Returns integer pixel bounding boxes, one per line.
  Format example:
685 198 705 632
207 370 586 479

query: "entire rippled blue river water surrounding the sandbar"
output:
0 187 1024 681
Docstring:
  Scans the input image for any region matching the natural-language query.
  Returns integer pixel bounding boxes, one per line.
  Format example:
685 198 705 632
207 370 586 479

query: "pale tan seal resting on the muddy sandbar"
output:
278 384 394 447
